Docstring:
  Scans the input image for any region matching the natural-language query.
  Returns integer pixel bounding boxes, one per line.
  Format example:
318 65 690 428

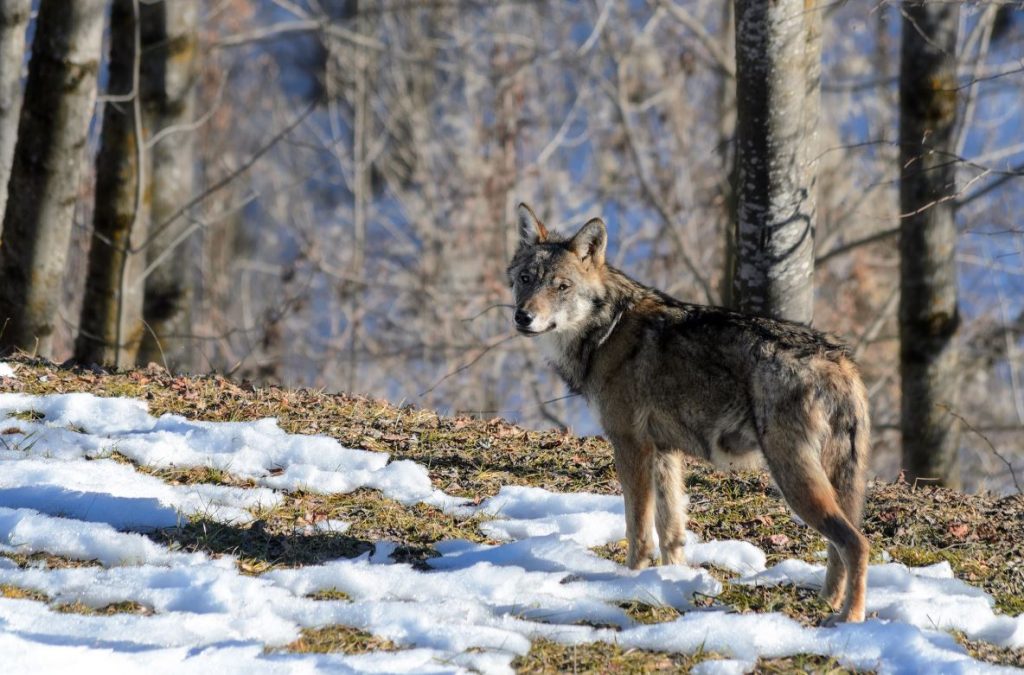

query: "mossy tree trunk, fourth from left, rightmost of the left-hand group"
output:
139 2 199 370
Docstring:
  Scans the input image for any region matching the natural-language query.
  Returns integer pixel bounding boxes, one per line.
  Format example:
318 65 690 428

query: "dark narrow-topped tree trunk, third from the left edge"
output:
75 0 147 368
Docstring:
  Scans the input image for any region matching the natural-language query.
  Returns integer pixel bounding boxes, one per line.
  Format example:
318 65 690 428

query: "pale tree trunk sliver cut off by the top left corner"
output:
0 0 32 229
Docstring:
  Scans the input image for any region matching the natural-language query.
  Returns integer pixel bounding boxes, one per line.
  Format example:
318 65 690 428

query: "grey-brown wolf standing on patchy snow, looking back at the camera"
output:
508 204 870 622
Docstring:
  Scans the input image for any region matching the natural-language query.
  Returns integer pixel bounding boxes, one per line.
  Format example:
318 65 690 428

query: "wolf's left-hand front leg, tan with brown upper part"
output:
612 437 654 569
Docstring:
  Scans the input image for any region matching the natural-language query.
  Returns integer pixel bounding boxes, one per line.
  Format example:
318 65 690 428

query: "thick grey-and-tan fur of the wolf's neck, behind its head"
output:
540 266 649 393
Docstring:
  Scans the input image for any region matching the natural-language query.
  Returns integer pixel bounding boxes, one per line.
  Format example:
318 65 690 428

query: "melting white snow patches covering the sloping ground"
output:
0 364 1024 675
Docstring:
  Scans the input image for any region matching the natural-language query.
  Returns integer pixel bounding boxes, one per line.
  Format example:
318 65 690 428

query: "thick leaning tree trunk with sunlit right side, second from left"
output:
0 0 106 356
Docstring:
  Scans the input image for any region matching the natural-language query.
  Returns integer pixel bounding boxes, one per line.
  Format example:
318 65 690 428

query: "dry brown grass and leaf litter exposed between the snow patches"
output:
0 358 1024 672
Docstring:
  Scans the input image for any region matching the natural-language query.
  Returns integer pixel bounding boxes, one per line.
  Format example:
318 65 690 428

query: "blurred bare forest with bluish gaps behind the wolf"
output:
0 0 1024 492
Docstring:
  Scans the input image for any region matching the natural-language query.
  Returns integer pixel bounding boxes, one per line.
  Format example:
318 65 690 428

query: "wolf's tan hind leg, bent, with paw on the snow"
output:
763 424 869 622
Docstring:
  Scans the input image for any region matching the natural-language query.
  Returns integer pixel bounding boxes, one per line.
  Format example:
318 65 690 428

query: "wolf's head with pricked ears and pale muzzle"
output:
508 204 608 337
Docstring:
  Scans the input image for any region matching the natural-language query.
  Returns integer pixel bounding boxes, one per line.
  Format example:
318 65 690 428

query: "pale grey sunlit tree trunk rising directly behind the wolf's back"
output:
733 0 821 324
